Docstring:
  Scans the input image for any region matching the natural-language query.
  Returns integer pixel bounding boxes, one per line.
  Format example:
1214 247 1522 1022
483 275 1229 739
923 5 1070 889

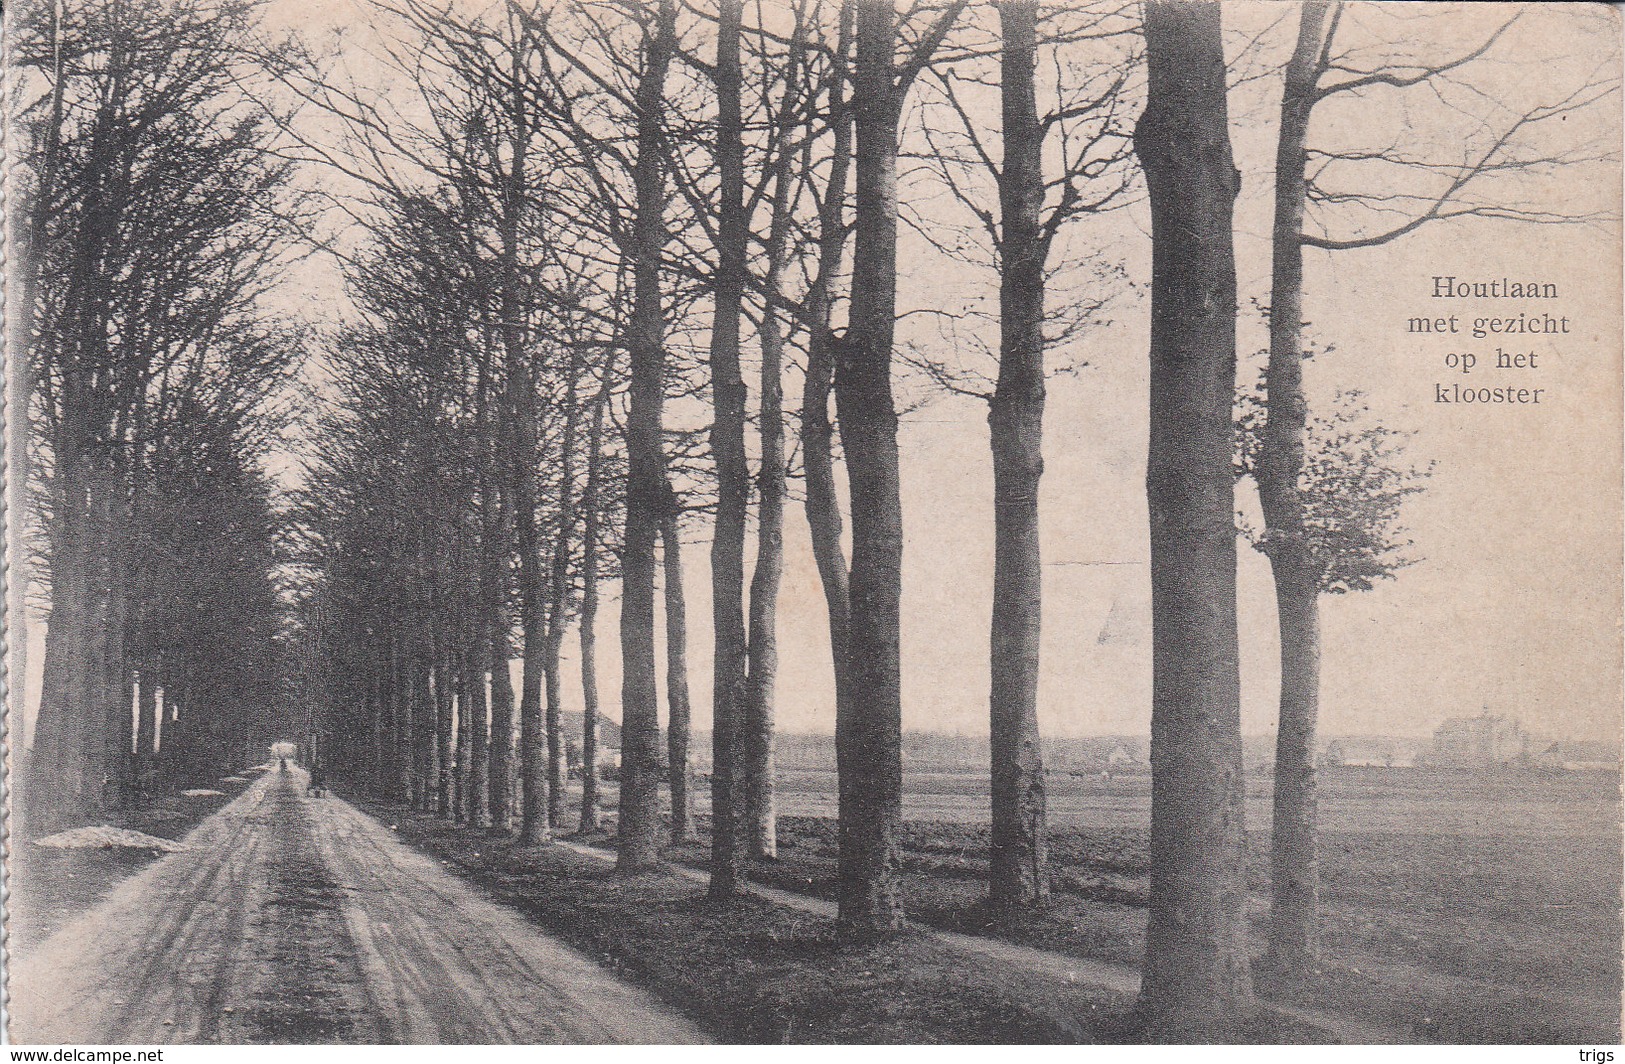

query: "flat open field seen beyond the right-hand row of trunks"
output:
617 768 1622 1043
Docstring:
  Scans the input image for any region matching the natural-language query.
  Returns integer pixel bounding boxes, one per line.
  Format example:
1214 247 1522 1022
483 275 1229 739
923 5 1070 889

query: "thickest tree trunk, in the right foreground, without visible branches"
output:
1134 0 1256 1040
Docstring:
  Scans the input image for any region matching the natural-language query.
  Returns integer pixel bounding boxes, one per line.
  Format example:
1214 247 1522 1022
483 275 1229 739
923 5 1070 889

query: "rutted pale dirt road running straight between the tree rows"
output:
10 770 705 1045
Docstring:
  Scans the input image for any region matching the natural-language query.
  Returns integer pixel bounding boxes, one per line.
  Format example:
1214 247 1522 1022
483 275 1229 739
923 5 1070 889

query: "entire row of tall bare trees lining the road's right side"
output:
240 0 1612 1035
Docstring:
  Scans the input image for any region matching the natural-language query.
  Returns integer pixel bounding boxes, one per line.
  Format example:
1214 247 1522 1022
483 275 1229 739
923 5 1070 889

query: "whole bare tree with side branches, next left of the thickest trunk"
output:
912 0 1133 911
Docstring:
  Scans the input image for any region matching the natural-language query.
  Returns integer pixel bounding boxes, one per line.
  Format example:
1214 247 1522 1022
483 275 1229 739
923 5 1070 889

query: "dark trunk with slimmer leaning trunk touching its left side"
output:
835 2 904 939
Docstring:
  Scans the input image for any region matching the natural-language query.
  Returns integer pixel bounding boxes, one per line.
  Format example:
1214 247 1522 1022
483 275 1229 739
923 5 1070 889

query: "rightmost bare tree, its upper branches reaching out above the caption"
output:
1251 0 1617 980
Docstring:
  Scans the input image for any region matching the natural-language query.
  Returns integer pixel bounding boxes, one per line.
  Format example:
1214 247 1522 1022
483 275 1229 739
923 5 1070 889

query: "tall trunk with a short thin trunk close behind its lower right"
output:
616 0 676 872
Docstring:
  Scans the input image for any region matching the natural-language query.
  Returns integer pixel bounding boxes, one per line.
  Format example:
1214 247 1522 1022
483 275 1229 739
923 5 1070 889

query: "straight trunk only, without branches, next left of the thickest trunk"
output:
988 0 1050 910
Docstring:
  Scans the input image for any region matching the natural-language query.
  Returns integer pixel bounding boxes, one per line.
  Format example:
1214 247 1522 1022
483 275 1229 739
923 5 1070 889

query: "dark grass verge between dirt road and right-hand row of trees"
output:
354 799 1323 1045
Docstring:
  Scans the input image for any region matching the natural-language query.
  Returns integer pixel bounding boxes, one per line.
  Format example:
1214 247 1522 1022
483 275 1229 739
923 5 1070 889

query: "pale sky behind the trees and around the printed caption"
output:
15 0 1622 739
